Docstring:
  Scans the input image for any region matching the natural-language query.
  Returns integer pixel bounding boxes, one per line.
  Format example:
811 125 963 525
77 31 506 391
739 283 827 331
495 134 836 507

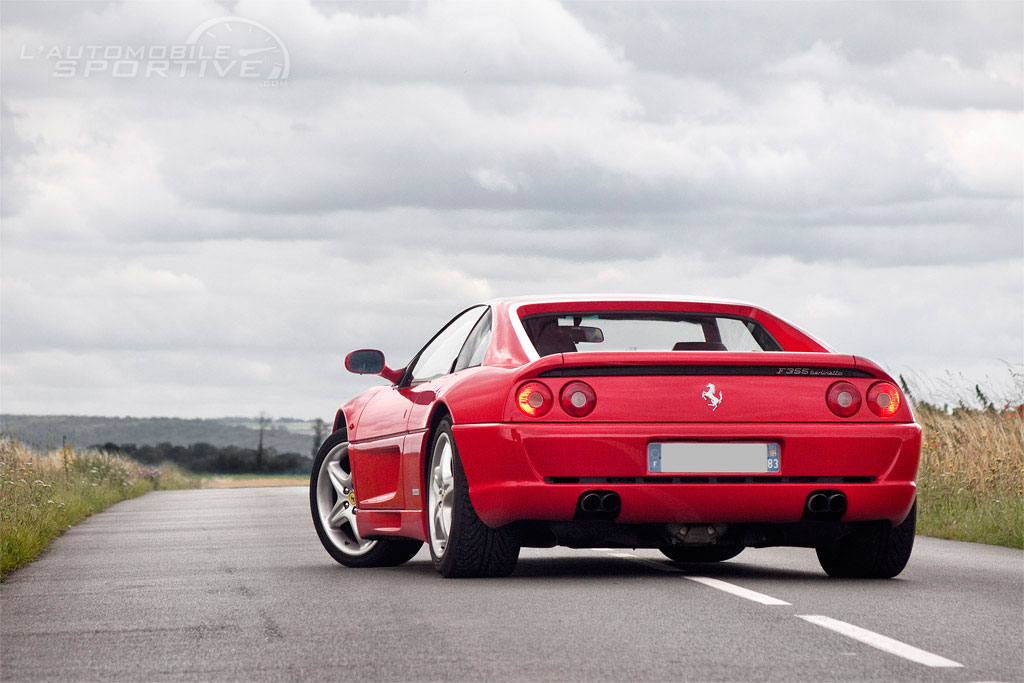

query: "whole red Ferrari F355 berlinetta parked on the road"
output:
309 297 921 578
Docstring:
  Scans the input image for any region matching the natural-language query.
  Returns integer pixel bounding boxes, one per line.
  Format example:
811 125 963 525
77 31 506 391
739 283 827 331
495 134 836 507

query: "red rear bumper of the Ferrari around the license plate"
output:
454 423 921 526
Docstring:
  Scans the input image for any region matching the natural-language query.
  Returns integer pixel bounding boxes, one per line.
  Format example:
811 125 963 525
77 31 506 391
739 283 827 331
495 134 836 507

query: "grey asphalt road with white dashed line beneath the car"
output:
0 487 1024 683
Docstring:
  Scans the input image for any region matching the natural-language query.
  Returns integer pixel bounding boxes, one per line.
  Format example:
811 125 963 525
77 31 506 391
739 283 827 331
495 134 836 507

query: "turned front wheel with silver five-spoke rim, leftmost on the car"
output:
309 429 423 567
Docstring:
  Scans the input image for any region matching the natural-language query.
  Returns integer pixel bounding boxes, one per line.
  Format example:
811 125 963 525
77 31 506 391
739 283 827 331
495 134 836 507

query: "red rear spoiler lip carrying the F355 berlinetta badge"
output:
517 351 891 380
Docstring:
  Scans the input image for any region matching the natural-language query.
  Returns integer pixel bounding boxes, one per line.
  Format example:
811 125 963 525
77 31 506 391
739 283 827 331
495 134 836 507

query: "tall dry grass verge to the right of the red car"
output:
916 404 1024 548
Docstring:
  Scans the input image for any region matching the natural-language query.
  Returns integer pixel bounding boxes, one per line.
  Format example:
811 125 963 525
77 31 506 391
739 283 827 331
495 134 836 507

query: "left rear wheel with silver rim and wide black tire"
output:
425 419 519 579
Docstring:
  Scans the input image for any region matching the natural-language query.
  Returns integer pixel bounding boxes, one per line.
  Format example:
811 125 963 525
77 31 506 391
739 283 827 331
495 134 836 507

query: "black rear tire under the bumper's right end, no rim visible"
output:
817 500 918 579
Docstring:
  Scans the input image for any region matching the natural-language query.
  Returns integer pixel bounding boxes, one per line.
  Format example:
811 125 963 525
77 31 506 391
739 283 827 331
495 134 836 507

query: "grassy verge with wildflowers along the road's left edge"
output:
0 439 200 581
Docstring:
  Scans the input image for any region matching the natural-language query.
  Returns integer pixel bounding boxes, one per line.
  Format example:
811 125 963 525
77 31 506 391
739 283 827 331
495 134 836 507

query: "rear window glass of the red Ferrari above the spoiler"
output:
522 311 782 355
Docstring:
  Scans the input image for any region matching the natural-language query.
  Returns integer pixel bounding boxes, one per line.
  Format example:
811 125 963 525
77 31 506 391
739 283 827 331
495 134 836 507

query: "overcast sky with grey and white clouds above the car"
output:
0 1 1024 418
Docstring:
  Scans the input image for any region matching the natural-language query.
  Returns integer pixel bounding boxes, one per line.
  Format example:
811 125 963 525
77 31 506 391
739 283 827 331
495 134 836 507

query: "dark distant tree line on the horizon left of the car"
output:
90 441 310 474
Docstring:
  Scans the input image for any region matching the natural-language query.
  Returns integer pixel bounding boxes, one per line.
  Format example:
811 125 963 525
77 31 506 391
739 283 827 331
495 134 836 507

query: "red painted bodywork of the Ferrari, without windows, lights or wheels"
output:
338 296 921 541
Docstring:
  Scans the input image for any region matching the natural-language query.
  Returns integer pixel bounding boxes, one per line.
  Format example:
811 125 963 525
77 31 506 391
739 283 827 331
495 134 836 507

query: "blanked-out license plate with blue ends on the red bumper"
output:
647 441 781 474
